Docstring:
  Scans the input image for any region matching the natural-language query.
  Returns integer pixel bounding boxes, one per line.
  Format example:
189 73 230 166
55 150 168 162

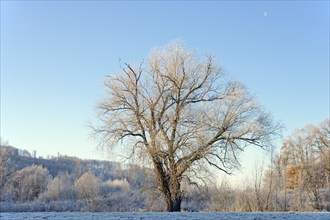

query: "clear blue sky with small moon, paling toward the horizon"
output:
1 1 329 182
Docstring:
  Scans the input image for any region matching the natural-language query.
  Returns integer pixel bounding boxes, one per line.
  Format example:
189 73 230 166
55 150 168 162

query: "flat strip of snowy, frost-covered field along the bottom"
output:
0 212 330 220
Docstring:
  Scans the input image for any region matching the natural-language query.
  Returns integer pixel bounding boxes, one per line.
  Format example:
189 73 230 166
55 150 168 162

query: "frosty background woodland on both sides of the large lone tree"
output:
0 119 330 212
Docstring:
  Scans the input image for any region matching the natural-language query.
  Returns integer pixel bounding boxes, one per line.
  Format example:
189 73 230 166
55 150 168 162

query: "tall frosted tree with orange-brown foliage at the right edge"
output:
281 119 330 210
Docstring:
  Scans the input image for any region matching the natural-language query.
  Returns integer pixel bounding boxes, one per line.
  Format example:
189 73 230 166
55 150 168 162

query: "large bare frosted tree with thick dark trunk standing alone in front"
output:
94 43 279 211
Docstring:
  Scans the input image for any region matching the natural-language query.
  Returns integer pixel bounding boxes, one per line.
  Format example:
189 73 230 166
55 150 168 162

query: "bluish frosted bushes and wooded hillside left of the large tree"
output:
0 145 160 211
